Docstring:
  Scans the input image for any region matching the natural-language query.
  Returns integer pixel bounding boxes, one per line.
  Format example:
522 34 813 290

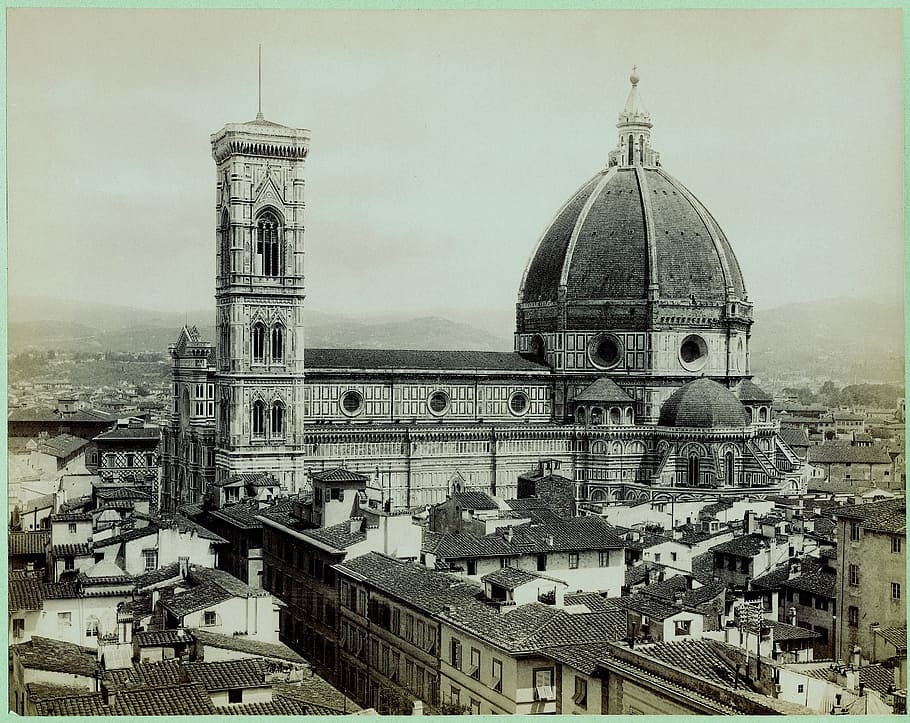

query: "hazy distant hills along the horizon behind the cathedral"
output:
8 298 904 384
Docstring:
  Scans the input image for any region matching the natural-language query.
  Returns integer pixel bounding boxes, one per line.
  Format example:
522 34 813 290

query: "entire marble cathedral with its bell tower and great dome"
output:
161 71 800 510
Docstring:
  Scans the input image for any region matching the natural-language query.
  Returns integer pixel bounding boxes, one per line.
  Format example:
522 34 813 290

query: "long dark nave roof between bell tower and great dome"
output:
304 349 550 373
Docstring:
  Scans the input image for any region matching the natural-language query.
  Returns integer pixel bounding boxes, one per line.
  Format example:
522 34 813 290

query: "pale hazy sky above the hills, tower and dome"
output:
7 9 904 326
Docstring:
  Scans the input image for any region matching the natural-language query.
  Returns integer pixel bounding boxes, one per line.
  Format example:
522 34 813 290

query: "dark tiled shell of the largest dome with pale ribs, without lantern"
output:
519 166 746 318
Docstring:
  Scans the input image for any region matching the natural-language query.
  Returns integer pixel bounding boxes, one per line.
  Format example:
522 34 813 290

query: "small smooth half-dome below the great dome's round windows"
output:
658 377 747 429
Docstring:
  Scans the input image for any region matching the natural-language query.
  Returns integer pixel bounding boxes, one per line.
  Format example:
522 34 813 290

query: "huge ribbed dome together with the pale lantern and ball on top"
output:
518 71 748 333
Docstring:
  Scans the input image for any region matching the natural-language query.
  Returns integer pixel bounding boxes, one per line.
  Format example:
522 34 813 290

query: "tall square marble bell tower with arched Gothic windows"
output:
211 112 310 492
